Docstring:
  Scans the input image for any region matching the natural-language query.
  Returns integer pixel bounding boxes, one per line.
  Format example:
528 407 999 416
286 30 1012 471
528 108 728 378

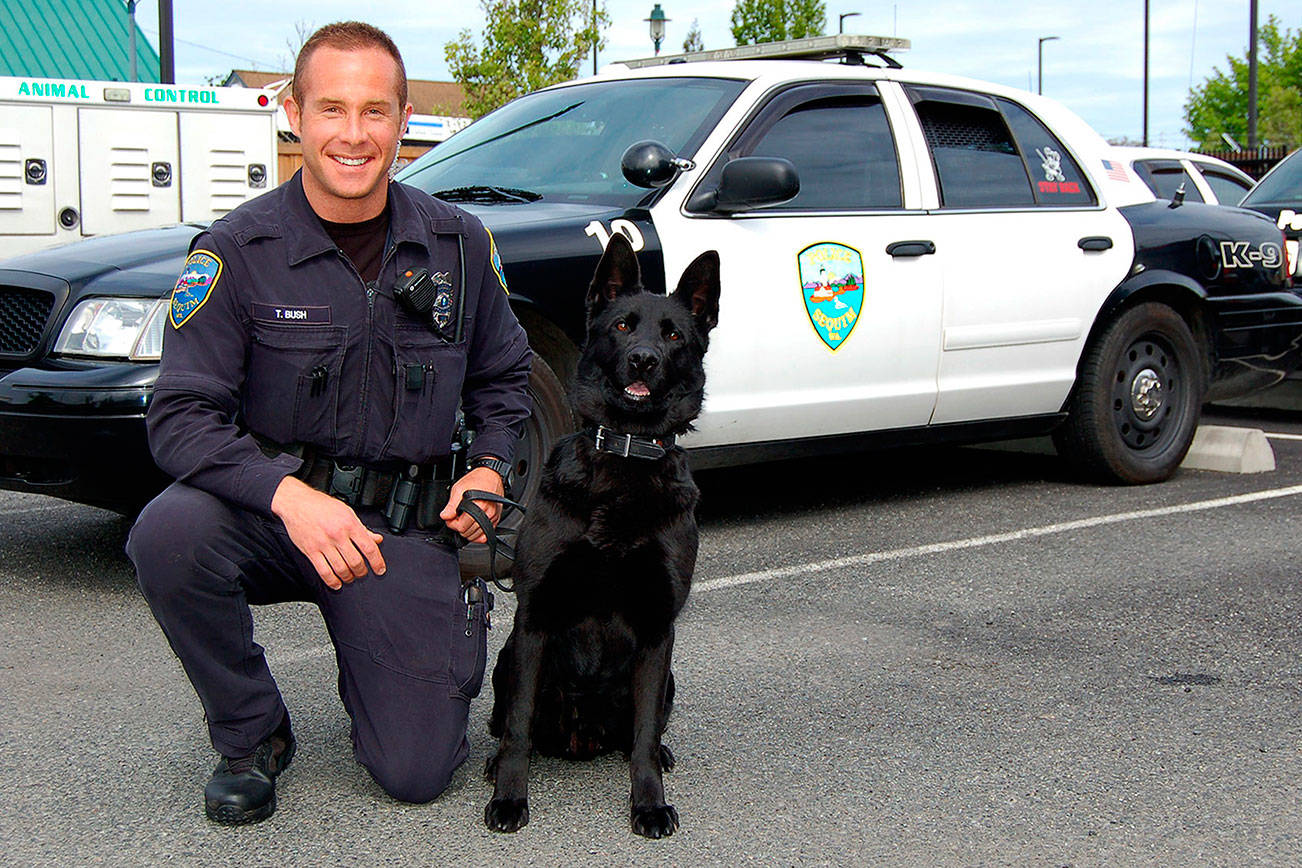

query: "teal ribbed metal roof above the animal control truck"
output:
0 0 159 82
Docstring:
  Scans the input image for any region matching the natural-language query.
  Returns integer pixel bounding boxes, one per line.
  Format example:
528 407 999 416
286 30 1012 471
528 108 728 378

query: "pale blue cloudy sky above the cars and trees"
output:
129 0 1302 147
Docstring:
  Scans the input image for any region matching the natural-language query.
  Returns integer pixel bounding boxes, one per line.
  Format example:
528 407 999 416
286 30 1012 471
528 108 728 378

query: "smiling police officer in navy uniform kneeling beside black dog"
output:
128 22 531 824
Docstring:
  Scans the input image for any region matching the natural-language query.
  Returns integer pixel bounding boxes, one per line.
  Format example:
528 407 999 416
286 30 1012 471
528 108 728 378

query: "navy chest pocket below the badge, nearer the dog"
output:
384 324 466 463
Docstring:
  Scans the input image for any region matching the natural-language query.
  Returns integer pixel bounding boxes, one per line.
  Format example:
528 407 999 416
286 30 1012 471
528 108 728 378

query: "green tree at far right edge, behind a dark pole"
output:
1185 16 1302 150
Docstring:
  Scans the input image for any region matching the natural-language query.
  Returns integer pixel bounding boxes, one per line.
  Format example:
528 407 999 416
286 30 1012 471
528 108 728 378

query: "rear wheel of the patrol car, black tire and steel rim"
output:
1053 302 1207 485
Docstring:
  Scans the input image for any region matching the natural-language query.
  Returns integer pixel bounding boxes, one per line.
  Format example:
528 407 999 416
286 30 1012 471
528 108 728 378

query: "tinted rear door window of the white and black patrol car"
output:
909 87 1035 208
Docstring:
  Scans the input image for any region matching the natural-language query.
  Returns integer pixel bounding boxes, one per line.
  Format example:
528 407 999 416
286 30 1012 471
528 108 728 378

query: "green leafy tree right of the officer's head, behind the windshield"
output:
443 0 611 117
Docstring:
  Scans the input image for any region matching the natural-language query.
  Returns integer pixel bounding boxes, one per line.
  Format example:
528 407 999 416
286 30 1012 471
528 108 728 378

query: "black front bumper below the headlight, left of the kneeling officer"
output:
0 364 168 514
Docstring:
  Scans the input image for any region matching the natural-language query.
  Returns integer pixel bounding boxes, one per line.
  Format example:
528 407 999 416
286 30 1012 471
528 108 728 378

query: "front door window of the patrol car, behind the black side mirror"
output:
746 94 902 211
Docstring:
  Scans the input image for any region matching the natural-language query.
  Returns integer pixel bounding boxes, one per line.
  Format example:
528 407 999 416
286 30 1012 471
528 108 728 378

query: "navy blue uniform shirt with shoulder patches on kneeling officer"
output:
147 174 533 515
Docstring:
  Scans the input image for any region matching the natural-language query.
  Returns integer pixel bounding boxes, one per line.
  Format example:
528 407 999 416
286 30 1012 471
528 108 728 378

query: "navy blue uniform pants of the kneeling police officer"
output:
126 483 486 802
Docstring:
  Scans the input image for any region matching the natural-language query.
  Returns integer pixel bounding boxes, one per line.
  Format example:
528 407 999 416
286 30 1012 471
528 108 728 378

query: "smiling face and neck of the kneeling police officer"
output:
285 46 411 223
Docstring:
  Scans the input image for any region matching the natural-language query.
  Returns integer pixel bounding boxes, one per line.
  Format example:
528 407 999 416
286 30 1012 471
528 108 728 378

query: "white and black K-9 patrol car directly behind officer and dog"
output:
0 36 1302 510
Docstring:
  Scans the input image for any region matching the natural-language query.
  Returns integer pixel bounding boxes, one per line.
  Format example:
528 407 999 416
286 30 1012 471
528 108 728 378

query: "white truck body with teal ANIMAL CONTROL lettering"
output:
0 77 277 259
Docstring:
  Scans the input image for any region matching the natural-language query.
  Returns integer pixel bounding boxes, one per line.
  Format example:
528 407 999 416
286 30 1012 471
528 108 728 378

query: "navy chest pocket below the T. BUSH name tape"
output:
242 323 348 452
